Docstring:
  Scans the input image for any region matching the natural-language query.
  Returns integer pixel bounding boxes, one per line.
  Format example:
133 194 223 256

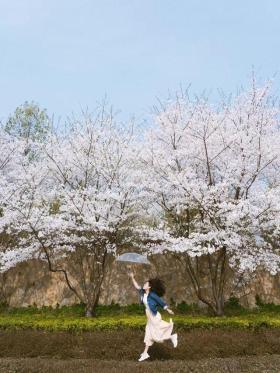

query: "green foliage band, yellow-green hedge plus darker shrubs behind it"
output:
0 299 280 333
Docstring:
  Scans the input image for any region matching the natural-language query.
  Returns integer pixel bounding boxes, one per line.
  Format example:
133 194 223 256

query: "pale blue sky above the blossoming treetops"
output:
0 0 280 121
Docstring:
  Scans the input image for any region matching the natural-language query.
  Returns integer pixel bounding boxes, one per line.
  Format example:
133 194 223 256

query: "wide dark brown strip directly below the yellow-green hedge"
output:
0 328 280 360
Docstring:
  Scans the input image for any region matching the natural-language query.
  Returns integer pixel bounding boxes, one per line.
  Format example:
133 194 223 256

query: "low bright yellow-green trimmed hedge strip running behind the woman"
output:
0 314 280 332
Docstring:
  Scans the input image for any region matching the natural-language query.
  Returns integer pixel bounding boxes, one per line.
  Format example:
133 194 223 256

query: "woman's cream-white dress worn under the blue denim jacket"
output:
143 293 173 346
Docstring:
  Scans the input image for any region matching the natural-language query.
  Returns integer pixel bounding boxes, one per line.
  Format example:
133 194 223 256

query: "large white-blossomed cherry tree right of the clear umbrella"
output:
142 82 280 315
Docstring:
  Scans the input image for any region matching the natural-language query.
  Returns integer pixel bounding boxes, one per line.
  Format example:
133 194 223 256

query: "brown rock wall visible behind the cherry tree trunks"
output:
1 257 280 307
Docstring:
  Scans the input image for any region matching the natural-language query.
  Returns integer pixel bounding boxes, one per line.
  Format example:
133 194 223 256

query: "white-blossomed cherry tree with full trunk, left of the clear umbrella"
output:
2 107 138 316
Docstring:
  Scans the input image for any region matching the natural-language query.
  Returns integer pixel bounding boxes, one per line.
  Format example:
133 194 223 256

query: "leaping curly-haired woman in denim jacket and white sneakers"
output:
129 273 177 361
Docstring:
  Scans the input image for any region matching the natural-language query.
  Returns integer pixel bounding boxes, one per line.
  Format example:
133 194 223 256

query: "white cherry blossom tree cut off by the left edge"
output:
0 129 46 272
